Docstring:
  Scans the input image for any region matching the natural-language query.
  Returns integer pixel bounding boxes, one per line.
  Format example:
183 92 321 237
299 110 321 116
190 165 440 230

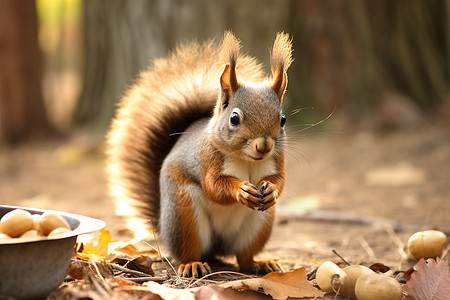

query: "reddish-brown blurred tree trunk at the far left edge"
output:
0 0 54 144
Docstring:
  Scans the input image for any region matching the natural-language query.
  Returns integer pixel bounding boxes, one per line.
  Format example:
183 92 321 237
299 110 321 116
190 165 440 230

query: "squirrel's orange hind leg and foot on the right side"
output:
236 209 283 274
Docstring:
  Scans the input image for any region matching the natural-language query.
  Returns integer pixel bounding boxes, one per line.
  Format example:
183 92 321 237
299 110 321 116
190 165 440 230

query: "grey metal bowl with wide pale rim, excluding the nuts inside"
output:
0 205 105 299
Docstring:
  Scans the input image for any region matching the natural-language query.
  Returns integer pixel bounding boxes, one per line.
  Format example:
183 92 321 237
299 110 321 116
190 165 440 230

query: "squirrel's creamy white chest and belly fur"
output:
184 159 276 253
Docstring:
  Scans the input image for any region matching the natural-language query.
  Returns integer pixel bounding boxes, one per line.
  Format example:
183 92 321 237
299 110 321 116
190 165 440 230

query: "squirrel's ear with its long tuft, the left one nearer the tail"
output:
220 31 241 93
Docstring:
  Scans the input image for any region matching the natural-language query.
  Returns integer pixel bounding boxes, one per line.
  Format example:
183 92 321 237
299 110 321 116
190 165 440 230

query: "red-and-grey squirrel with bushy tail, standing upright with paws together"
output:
107 31 293 277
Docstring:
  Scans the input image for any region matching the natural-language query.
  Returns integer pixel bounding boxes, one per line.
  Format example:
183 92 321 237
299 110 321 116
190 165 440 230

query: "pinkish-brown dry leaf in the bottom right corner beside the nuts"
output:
403 258 450 300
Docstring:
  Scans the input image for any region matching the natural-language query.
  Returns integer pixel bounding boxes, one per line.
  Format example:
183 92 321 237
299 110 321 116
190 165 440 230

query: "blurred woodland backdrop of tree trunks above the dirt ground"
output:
0 0 450 144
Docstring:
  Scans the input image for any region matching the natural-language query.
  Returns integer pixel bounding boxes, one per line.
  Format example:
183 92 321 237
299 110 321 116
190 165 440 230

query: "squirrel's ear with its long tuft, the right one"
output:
270 32 293 101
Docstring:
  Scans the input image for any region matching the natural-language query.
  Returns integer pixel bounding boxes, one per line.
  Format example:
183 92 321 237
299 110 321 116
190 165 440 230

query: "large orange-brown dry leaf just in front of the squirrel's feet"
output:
220 268 324 299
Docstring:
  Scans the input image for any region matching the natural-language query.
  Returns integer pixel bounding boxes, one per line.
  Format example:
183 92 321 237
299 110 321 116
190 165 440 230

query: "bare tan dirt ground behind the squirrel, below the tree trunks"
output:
0 115 450 276
